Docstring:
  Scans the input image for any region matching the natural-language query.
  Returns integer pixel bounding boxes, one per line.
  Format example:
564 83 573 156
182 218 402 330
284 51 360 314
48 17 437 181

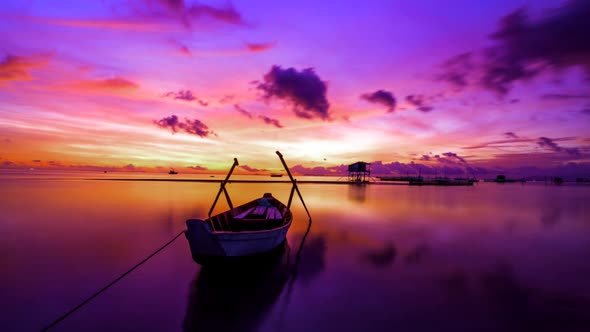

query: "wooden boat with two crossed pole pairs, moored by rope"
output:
185 151 311 264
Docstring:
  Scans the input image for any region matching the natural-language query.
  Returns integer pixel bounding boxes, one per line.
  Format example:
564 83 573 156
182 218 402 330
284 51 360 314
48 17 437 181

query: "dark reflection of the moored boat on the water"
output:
184 241 290 331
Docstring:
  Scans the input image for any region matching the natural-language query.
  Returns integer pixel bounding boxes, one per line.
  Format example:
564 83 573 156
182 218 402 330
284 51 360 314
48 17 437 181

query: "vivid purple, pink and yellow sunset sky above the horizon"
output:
0 0 590 177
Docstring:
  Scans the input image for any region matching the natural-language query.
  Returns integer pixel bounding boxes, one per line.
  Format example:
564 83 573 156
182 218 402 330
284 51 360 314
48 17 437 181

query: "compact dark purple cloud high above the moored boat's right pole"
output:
257 65 330 120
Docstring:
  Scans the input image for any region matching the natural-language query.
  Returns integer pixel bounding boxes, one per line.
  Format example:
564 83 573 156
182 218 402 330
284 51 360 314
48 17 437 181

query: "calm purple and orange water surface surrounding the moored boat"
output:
0 173 590 331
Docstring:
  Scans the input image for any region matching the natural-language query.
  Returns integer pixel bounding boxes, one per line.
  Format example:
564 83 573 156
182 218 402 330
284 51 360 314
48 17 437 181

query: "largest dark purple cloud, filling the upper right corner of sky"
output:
438 0 590 96
